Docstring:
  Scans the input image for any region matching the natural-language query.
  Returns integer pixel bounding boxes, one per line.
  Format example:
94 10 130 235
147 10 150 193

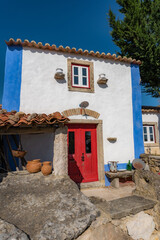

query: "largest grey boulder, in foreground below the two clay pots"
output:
0 173 98 240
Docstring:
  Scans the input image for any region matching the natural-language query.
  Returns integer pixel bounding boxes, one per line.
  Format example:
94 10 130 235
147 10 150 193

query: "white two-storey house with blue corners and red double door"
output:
2 39 144 185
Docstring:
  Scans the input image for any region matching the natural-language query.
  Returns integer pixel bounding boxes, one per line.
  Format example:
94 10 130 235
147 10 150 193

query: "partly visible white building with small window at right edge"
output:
142 106 160 155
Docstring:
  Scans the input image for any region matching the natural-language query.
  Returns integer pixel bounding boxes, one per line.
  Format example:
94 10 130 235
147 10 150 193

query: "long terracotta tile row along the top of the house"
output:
5 38 141 65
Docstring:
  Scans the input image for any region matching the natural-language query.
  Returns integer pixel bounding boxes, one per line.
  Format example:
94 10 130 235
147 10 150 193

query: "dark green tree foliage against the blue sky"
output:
108 0 160 97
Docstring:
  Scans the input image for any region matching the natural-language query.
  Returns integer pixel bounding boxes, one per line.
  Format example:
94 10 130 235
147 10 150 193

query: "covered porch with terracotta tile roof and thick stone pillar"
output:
0 110 69 175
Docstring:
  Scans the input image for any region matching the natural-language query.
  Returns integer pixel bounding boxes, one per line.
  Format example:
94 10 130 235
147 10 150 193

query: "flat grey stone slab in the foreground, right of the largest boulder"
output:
93 195 157 219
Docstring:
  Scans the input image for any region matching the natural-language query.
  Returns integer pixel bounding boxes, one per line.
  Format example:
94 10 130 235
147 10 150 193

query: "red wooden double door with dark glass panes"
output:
68 124 98 183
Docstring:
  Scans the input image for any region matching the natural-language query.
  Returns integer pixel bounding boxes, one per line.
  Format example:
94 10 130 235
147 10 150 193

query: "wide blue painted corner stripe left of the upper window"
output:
2 46 22 111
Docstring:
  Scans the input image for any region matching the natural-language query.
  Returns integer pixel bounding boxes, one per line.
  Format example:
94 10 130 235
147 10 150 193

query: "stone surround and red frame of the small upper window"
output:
67 59 94 93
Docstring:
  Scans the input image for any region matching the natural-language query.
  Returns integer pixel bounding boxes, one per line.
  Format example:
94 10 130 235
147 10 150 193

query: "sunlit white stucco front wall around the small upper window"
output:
20 48 134 164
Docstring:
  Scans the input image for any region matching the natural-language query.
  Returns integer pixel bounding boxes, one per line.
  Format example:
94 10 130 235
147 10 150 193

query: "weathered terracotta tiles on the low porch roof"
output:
0 109 69 127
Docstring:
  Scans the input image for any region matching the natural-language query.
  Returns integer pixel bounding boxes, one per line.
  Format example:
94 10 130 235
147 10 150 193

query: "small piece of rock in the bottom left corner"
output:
0 219 29 240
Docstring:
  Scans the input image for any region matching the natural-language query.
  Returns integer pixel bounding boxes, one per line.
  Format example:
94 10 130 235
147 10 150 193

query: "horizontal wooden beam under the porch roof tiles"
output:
0 126 56 135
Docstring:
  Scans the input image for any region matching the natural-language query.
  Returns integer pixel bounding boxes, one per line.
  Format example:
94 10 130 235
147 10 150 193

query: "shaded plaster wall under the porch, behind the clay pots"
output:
21 133 54 162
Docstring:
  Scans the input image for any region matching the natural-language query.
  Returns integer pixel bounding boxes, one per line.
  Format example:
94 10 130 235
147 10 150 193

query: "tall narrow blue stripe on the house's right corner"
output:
131 64 144 158
